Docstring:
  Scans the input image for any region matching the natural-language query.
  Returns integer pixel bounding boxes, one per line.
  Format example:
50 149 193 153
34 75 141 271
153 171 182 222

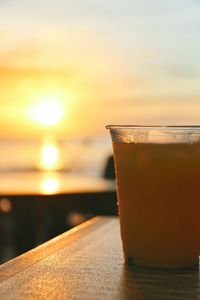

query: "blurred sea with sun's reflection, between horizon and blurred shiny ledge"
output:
0 137 112 176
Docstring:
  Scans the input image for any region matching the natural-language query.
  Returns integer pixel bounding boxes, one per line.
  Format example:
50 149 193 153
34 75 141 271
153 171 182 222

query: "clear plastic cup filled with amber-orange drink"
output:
106 125 200 268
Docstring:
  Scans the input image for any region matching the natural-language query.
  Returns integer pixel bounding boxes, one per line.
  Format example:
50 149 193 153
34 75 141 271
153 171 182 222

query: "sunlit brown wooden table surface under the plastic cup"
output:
0 217 200 300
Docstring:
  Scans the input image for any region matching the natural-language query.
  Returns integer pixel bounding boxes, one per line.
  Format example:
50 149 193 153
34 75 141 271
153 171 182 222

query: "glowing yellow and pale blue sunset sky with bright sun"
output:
0 0 200 137
